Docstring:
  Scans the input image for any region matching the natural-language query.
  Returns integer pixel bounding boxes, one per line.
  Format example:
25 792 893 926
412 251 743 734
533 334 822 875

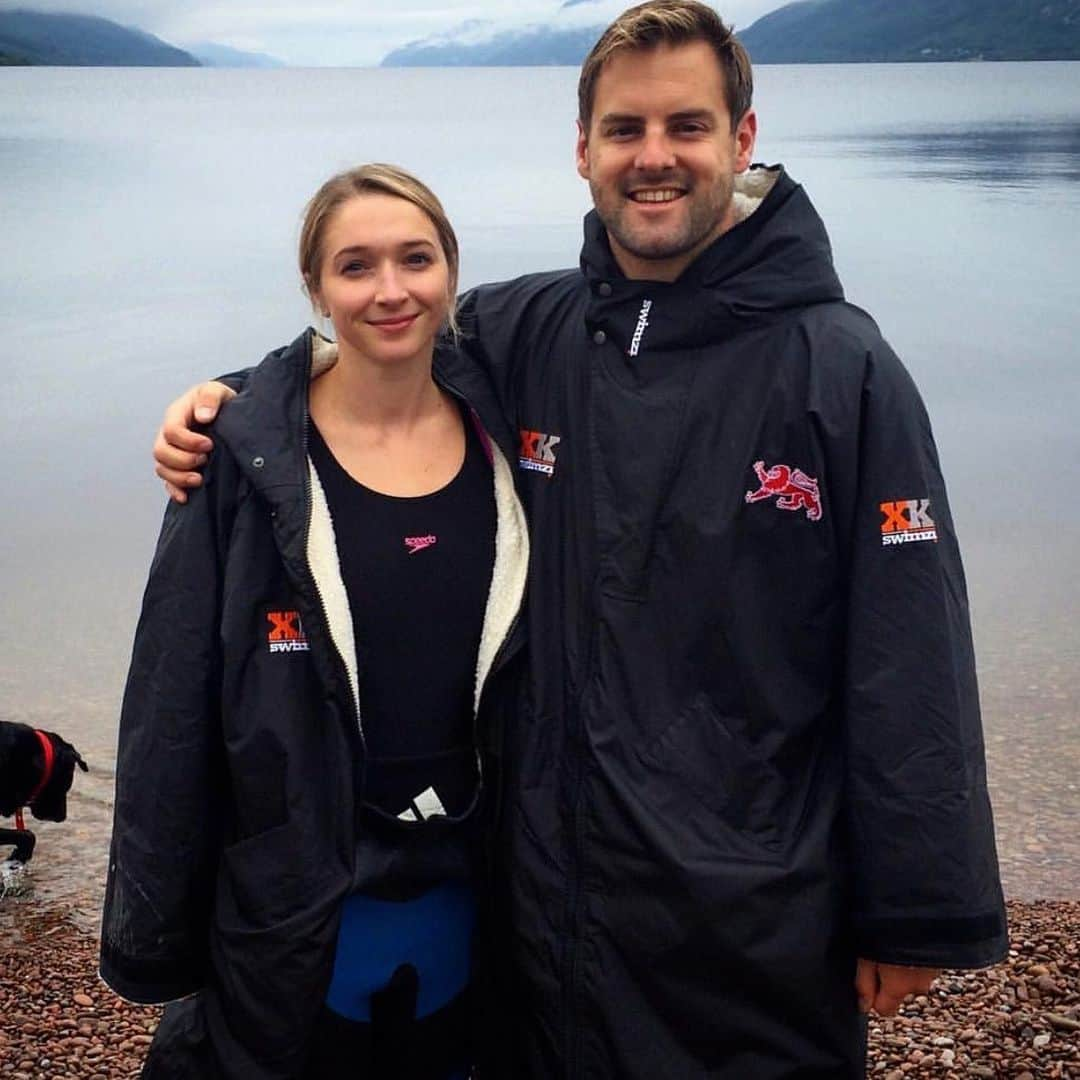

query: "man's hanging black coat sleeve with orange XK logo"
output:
845 340 1008 968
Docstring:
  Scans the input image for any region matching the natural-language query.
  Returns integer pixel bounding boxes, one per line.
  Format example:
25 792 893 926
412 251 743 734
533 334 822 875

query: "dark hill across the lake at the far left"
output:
0 10 200 67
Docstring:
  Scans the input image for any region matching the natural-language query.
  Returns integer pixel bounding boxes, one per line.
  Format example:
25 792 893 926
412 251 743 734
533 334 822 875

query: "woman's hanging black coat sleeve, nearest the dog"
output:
100 451 235 1003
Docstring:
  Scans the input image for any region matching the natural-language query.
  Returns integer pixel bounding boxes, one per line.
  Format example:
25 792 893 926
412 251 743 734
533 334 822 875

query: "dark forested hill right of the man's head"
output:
739 0 1080 64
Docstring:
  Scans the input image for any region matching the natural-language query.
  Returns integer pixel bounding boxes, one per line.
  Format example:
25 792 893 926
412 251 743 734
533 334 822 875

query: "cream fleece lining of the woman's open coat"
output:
307 333 529 734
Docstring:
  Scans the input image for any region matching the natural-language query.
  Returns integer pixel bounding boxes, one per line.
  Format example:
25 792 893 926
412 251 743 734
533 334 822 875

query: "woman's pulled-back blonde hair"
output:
299 162 460 337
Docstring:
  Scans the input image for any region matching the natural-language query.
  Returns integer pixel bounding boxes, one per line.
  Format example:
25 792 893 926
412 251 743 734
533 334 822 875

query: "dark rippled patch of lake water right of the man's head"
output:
829 122 1080 188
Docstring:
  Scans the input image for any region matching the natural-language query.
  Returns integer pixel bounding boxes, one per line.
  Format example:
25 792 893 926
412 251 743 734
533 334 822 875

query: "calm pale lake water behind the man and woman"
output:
0 63 1080 921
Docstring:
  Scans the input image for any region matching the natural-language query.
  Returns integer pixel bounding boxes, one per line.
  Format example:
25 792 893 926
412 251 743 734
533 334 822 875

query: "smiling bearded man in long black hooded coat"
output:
158 0 1007 1080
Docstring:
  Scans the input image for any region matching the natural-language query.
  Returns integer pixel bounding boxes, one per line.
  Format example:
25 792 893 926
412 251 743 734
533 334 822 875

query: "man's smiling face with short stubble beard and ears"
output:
578 41 757 281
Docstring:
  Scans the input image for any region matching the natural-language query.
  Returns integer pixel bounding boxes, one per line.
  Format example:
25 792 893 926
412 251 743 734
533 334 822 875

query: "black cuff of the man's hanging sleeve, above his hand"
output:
854 910 1009 970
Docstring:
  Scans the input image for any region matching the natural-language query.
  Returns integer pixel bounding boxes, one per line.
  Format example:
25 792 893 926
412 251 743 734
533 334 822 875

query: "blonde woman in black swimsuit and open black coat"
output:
102 165 527 1080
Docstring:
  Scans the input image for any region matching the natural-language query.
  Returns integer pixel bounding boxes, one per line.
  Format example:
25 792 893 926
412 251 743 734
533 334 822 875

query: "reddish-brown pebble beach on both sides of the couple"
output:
0 896 1080 1080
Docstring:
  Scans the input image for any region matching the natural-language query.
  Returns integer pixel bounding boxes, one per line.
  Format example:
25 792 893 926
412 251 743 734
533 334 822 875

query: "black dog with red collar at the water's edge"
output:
0 720 87 863
